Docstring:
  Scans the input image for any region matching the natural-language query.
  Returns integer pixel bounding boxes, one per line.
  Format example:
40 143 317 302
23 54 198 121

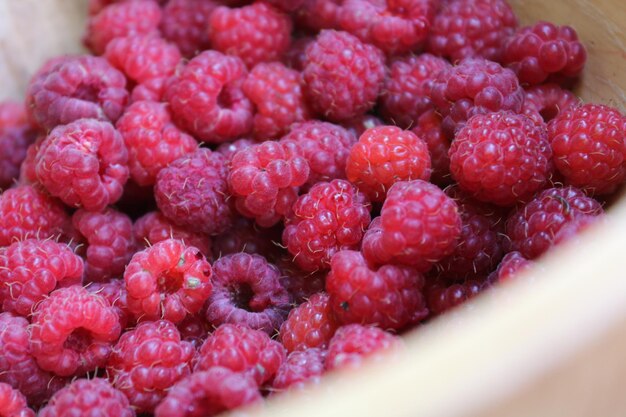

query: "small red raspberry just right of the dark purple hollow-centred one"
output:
279 293 338 352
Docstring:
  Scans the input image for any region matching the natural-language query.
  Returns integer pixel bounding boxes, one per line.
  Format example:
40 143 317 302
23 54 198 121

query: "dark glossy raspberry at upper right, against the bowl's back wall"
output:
503 21 587 85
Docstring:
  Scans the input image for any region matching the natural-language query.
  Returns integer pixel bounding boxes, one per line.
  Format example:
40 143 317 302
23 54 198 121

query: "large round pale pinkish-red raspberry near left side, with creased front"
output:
35 119 128 211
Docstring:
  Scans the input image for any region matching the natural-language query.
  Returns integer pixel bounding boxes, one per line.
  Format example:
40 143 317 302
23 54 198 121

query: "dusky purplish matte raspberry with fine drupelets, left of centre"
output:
154 148 233 234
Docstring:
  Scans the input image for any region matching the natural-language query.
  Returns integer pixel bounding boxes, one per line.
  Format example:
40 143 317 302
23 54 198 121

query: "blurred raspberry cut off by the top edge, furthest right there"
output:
428 0 518 62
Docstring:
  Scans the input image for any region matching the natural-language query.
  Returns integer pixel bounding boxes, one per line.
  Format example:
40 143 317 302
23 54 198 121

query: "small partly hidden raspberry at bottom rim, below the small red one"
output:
272 349 326 393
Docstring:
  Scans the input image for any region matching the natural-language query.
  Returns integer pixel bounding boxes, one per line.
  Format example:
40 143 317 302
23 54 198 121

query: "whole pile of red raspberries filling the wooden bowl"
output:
0 0 626 417
